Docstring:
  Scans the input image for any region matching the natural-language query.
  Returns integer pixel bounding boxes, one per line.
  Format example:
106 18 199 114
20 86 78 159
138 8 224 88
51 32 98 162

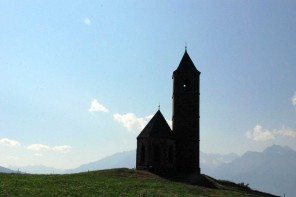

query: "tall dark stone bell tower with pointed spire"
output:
172 48 200 174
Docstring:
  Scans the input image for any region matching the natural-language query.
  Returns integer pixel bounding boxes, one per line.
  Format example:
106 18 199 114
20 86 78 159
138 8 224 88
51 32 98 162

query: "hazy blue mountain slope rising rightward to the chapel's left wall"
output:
64 150 136 173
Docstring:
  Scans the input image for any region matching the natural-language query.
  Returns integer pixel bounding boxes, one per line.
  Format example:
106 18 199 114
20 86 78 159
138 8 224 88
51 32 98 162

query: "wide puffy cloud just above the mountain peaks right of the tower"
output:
245 124 296 141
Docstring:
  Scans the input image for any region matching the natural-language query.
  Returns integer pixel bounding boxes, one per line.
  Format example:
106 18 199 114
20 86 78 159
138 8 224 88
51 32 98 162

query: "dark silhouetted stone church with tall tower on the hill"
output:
136 48 200 174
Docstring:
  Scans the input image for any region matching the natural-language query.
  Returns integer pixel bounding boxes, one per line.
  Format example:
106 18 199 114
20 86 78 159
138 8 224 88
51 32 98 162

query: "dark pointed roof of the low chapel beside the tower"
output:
137 110 173 139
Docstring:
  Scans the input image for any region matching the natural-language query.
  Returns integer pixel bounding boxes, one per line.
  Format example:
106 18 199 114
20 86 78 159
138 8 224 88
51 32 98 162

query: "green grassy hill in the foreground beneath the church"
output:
0 169 278 197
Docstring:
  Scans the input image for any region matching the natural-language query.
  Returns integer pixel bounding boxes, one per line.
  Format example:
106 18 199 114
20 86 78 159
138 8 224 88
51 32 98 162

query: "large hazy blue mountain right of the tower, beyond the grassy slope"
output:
211 145 296 196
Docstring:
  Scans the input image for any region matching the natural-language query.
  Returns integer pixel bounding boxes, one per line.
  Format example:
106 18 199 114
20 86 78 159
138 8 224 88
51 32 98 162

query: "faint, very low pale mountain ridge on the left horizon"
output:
13 165 65 174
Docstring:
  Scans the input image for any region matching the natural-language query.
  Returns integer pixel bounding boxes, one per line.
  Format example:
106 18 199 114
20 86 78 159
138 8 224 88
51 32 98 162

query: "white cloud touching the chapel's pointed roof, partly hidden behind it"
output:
113 113 172 134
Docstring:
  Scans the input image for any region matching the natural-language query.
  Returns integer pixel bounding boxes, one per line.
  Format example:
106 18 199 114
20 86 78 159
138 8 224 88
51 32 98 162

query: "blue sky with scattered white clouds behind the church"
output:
0 0 296 168
